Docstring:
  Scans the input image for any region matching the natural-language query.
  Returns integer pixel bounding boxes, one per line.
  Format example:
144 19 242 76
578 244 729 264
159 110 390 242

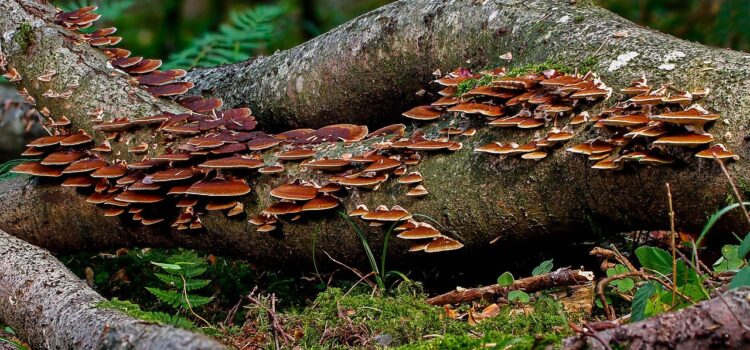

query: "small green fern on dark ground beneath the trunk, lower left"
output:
146 250 213 310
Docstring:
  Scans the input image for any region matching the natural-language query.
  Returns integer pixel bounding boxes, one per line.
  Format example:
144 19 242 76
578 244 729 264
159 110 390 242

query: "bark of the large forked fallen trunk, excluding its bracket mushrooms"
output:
0 0 750 263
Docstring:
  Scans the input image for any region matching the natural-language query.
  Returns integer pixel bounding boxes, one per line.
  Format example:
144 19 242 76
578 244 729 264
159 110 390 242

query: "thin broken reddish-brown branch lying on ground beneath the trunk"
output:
427 268 594 305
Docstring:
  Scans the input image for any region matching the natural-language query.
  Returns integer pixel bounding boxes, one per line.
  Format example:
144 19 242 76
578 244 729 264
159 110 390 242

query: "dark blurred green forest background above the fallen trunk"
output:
54 0 750 68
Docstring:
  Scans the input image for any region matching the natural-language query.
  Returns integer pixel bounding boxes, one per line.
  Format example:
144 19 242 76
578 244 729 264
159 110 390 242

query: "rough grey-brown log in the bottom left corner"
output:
0 231 224 350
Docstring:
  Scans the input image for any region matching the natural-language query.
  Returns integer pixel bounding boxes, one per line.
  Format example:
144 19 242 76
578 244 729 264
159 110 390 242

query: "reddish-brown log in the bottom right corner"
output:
564 287 750 349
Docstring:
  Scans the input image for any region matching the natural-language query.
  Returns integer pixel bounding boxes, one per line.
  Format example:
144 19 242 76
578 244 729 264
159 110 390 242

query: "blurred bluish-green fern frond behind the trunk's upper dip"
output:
164 5 286 69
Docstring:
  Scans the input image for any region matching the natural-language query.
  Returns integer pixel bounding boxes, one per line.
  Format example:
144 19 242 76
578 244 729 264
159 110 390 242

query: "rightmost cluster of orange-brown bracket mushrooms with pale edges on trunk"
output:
567 77 738 170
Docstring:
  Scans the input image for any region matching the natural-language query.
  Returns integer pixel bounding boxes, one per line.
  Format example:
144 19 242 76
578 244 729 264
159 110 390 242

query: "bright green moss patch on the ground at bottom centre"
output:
286 285 568 349
